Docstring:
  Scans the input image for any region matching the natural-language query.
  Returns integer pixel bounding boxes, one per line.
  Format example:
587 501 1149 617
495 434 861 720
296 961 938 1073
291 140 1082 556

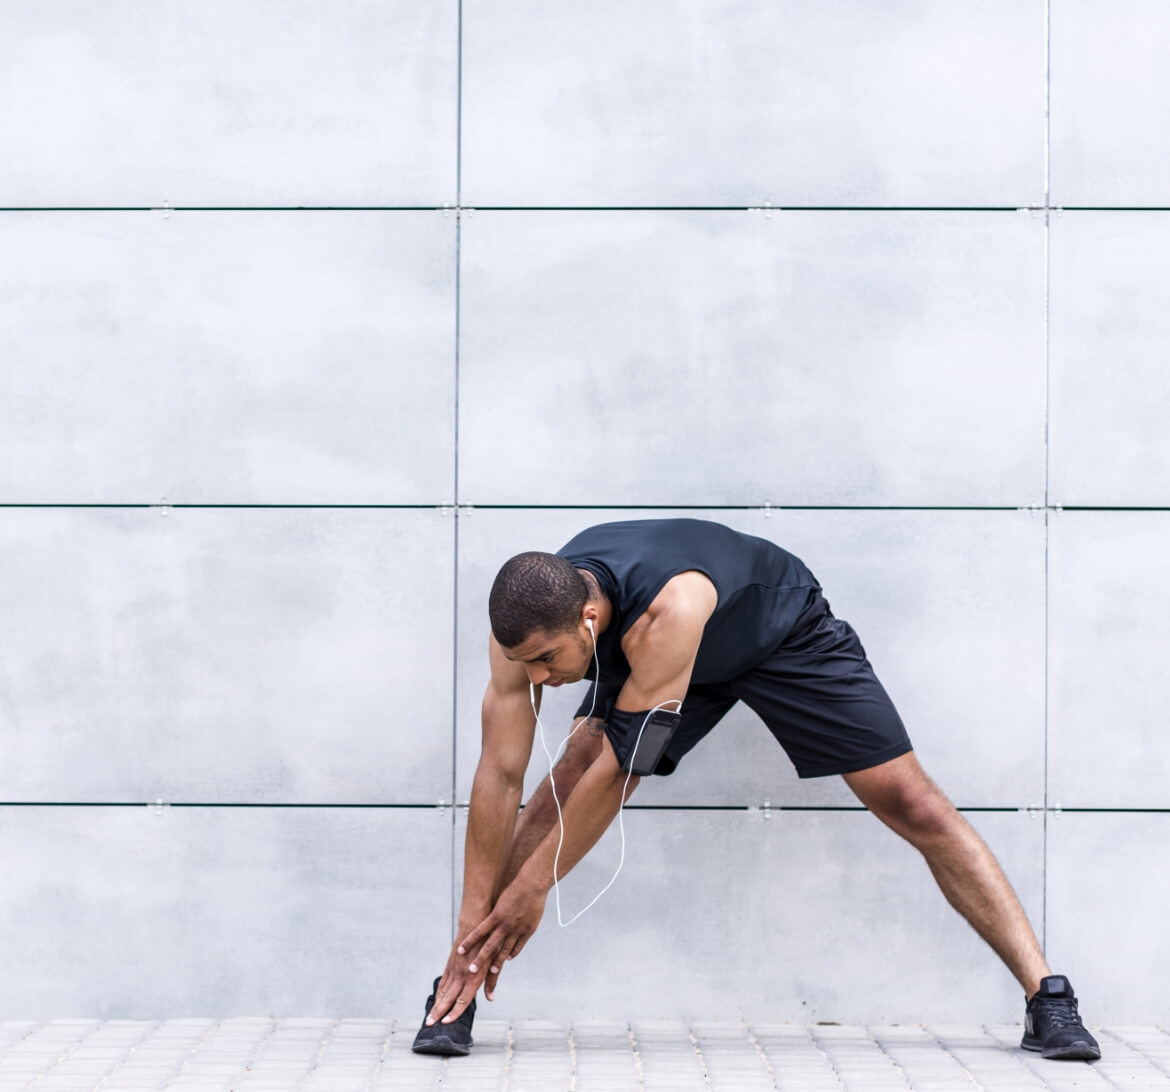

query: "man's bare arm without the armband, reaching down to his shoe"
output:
429 637 539 1021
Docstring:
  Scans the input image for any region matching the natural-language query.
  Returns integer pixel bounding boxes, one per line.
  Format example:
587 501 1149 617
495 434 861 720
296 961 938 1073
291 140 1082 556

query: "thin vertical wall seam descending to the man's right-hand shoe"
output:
1040 0 1052 952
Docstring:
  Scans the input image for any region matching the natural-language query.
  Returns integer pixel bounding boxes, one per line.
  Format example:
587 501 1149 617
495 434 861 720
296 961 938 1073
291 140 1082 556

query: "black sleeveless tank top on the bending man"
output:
557 520 820 684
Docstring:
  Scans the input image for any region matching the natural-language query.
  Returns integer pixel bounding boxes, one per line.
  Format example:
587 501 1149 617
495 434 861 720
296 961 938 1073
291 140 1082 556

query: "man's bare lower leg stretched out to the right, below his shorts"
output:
844 753 1052 997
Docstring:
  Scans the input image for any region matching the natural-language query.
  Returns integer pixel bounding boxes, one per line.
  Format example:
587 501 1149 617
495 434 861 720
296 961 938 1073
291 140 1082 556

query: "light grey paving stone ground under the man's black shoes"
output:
0 1018 1170 1092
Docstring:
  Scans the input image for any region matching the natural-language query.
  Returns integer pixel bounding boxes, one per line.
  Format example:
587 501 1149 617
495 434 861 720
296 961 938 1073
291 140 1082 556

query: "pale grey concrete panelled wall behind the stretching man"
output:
0 0 1170 1023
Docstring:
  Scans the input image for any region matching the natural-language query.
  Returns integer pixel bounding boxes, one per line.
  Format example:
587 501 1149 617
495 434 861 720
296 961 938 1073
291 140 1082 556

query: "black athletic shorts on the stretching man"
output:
577 592 913 777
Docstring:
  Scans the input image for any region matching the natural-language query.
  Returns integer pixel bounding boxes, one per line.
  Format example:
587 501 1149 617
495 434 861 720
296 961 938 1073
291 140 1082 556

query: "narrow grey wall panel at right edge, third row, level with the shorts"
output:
1048 511 1170 808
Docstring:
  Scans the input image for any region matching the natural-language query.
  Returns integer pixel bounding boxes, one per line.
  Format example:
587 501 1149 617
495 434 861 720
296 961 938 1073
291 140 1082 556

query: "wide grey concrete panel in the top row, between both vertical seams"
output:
462 0 1045 207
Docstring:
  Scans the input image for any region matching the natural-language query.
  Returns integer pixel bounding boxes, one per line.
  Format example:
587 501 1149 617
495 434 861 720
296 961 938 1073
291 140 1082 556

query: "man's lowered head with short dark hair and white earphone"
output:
488 551 598 686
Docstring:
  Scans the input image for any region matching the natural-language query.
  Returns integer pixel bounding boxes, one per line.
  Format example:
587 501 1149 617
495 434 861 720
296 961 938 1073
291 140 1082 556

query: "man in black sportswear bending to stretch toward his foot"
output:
414 520 1101 1060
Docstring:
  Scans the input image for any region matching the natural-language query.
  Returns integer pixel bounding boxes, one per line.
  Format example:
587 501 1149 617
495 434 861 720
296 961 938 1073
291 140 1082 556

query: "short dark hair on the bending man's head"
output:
488 550 589 648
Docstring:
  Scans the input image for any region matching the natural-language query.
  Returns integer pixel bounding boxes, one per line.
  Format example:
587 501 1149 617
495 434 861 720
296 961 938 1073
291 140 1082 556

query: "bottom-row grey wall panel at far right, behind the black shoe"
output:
1047 812 1170 1020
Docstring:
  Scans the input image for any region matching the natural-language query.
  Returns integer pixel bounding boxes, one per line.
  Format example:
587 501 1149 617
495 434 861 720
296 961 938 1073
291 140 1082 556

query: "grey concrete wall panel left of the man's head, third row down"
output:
0 508 454 804
